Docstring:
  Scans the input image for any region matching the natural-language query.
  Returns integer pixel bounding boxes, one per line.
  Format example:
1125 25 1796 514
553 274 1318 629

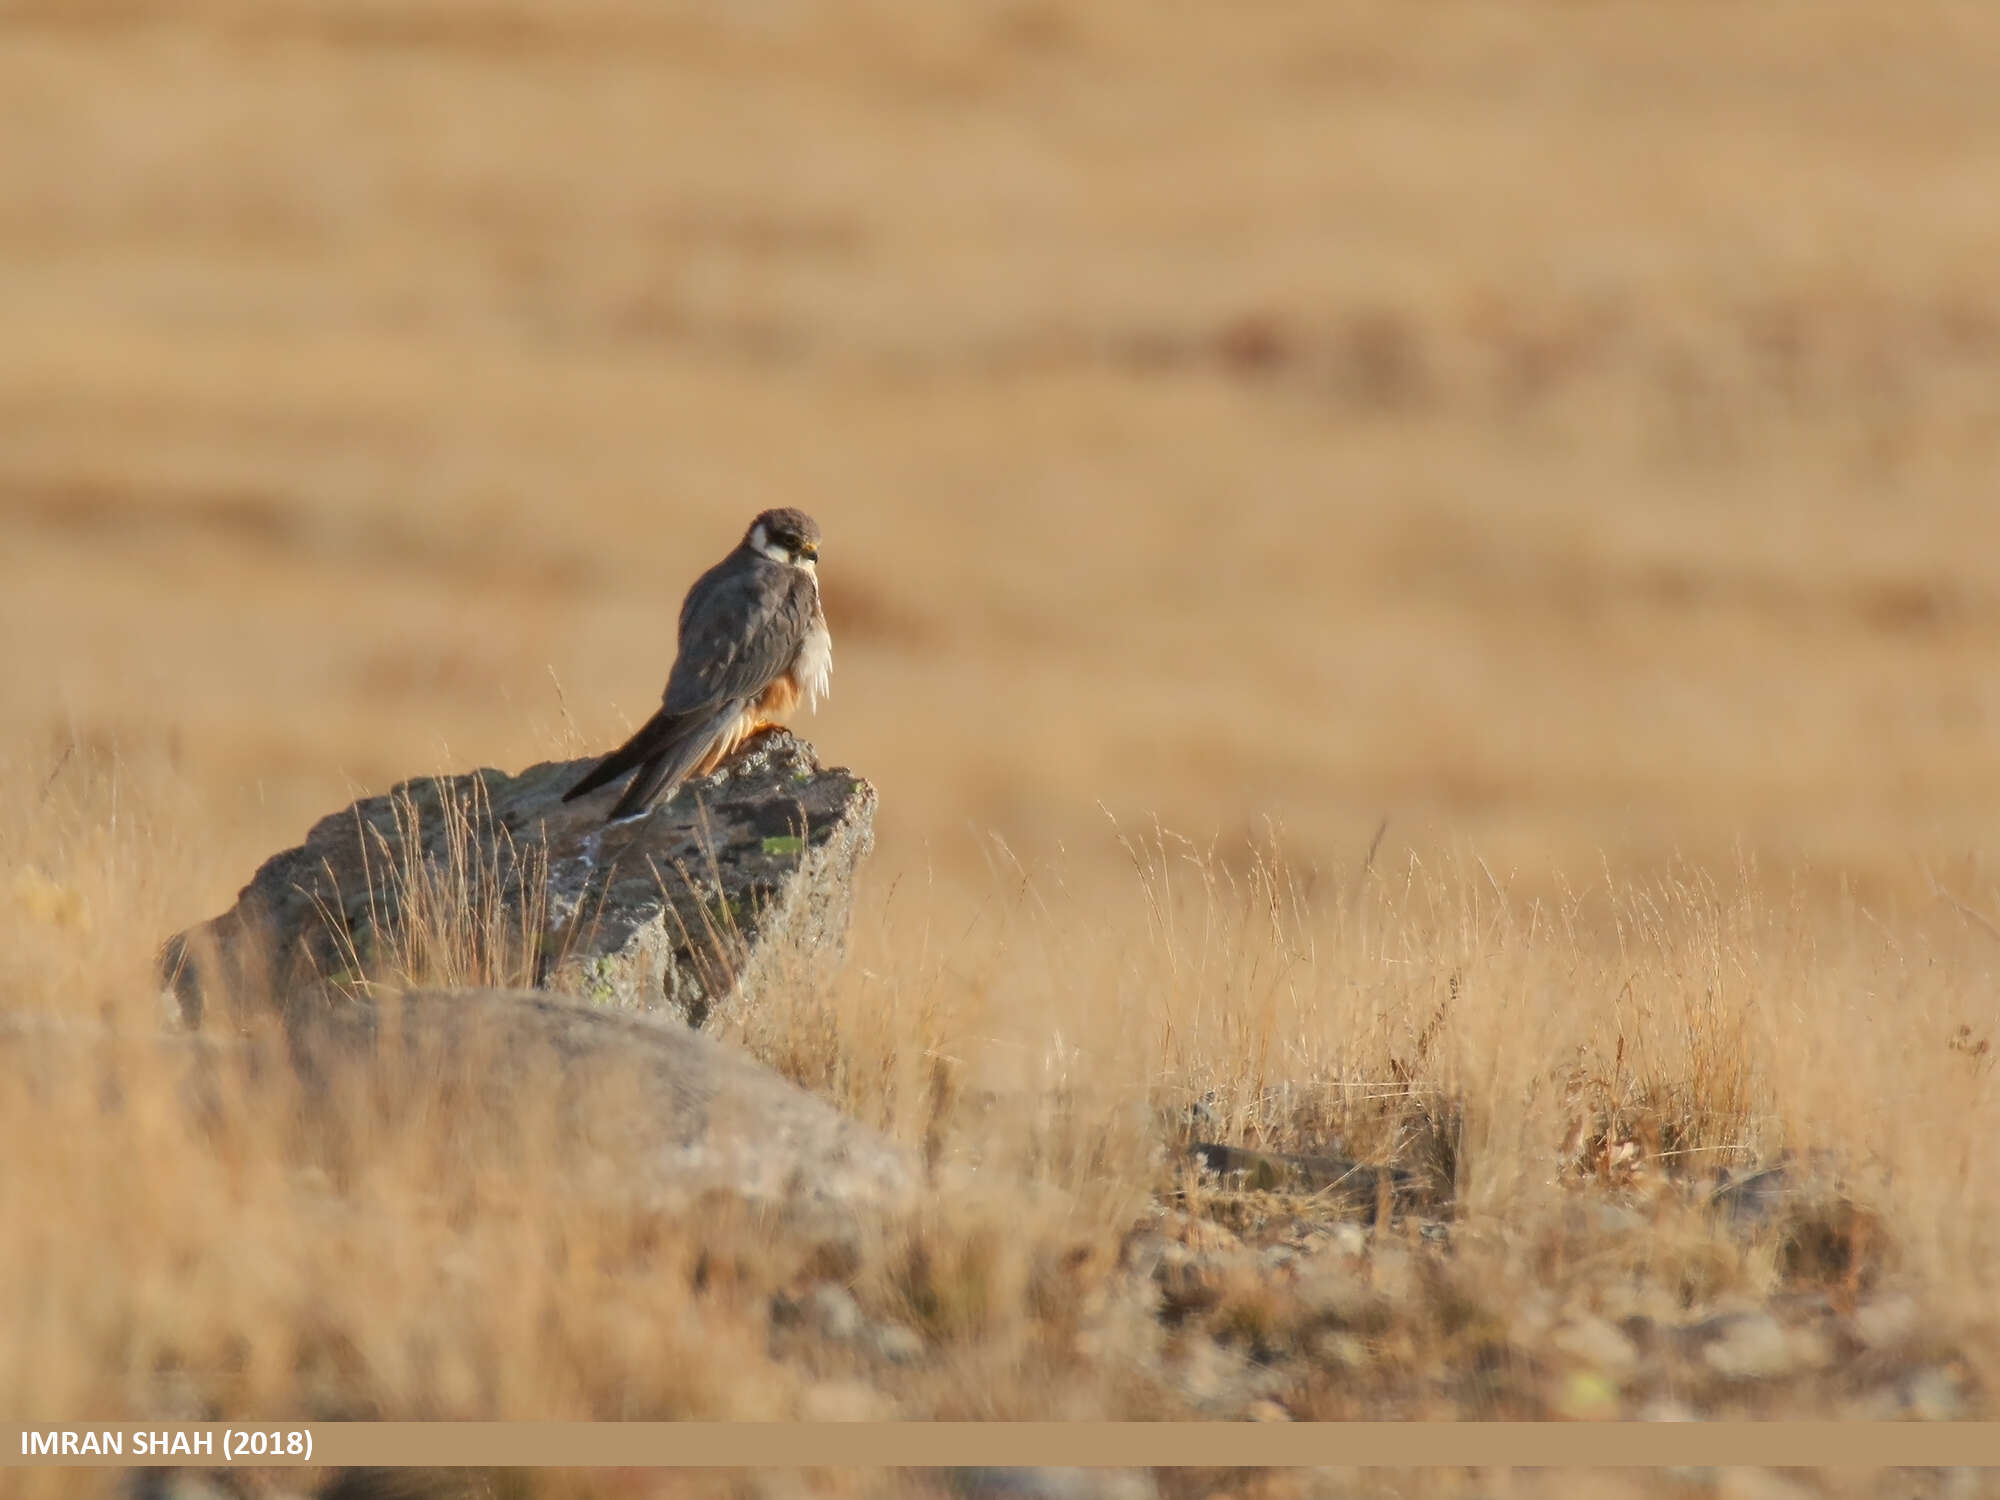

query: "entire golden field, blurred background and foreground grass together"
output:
0 0 2000 1494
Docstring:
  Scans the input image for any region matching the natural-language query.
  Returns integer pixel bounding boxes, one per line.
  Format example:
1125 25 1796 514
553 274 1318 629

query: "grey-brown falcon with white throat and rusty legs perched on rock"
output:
562 506 834 822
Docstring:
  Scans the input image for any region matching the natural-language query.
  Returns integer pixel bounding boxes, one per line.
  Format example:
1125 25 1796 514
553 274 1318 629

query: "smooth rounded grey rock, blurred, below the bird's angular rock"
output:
0 990 922 1250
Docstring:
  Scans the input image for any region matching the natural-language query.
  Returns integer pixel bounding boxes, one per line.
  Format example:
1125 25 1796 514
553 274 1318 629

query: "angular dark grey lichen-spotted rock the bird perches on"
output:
162 730 876 1026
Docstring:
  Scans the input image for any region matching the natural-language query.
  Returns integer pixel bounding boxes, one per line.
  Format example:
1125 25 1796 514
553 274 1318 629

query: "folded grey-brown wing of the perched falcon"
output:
662 556 814 714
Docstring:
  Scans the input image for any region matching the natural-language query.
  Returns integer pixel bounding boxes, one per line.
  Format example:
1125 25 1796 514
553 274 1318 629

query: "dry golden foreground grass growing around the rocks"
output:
0 764 2000 1456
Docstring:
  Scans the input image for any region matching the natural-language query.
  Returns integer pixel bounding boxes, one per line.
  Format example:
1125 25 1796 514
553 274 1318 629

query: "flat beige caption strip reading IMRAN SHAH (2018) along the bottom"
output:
11 1422 2000 1468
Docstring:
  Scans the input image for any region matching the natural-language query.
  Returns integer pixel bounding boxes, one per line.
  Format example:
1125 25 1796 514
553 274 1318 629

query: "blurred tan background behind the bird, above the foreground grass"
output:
0 0 2000 920
